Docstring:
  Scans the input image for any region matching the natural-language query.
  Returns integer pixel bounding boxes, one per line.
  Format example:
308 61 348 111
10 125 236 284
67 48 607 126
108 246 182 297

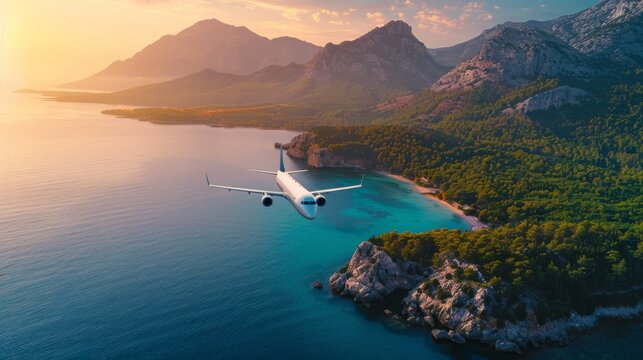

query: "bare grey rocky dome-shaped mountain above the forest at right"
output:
431 26 597 91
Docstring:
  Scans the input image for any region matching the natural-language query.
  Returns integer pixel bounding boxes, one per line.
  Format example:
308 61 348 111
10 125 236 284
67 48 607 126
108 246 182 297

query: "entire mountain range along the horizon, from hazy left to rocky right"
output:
59 0 643 107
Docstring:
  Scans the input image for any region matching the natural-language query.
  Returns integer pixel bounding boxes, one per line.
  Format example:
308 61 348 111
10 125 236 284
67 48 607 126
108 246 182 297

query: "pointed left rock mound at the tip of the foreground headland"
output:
330 242 424 304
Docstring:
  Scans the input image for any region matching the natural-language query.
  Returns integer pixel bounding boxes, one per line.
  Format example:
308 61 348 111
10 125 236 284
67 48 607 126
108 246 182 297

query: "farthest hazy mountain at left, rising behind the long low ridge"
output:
62 19 320 91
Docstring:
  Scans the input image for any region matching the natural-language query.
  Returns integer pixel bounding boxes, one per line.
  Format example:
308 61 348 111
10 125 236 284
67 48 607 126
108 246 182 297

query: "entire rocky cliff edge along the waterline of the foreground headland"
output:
329 242 643 352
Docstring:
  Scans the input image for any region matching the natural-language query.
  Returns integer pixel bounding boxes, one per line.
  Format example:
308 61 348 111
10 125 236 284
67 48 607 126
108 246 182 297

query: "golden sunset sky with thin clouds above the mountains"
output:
0 0 598 90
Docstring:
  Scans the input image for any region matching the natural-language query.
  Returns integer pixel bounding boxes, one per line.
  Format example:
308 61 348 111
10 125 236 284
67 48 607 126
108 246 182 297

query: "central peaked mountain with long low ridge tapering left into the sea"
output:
59 21 445 106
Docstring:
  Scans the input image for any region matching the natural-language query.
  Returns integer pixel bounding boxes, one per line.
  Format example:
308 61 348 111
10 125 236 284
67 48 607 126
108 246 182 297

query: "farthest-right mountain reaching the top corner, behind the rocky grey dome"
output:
429 0 643 67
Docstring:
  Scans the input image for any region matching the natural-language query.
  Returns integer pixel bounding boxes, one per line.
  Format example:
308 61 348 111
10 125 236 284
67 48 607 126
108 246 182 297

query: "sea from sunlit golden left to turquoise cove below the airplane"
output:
0 95 643 359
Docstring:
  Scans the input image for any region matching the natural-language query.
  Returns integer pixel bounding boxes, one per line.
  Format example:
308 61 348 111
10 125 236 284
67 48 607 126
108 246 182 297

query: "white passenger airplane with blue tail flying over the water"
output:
205 146 364 220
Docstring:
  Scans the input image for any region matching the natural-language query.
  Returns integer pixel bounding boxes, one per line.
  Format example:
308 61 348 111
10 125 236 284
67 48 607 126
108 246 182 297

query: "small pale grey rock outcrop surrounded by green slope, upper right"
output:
503 86 591 114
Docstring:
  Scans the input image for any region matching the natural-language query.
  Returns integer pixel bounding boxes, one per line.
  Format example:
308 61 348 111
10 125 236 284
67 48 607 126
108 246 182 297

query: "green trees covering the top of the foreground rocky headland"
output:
370 221 643 319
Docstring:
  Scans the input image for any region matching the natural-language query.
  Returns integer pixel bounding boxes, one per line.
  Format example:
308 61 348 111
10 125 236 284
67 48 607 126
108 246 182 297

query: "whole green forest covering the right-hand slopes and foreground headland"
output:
312 73 643 320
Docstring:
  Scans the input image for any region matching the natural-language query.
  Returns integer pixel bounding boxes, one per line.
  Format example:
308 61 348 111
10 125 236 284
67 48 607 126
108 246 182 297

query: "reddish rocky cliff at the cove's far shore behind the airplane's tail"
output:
287 132 377 170
